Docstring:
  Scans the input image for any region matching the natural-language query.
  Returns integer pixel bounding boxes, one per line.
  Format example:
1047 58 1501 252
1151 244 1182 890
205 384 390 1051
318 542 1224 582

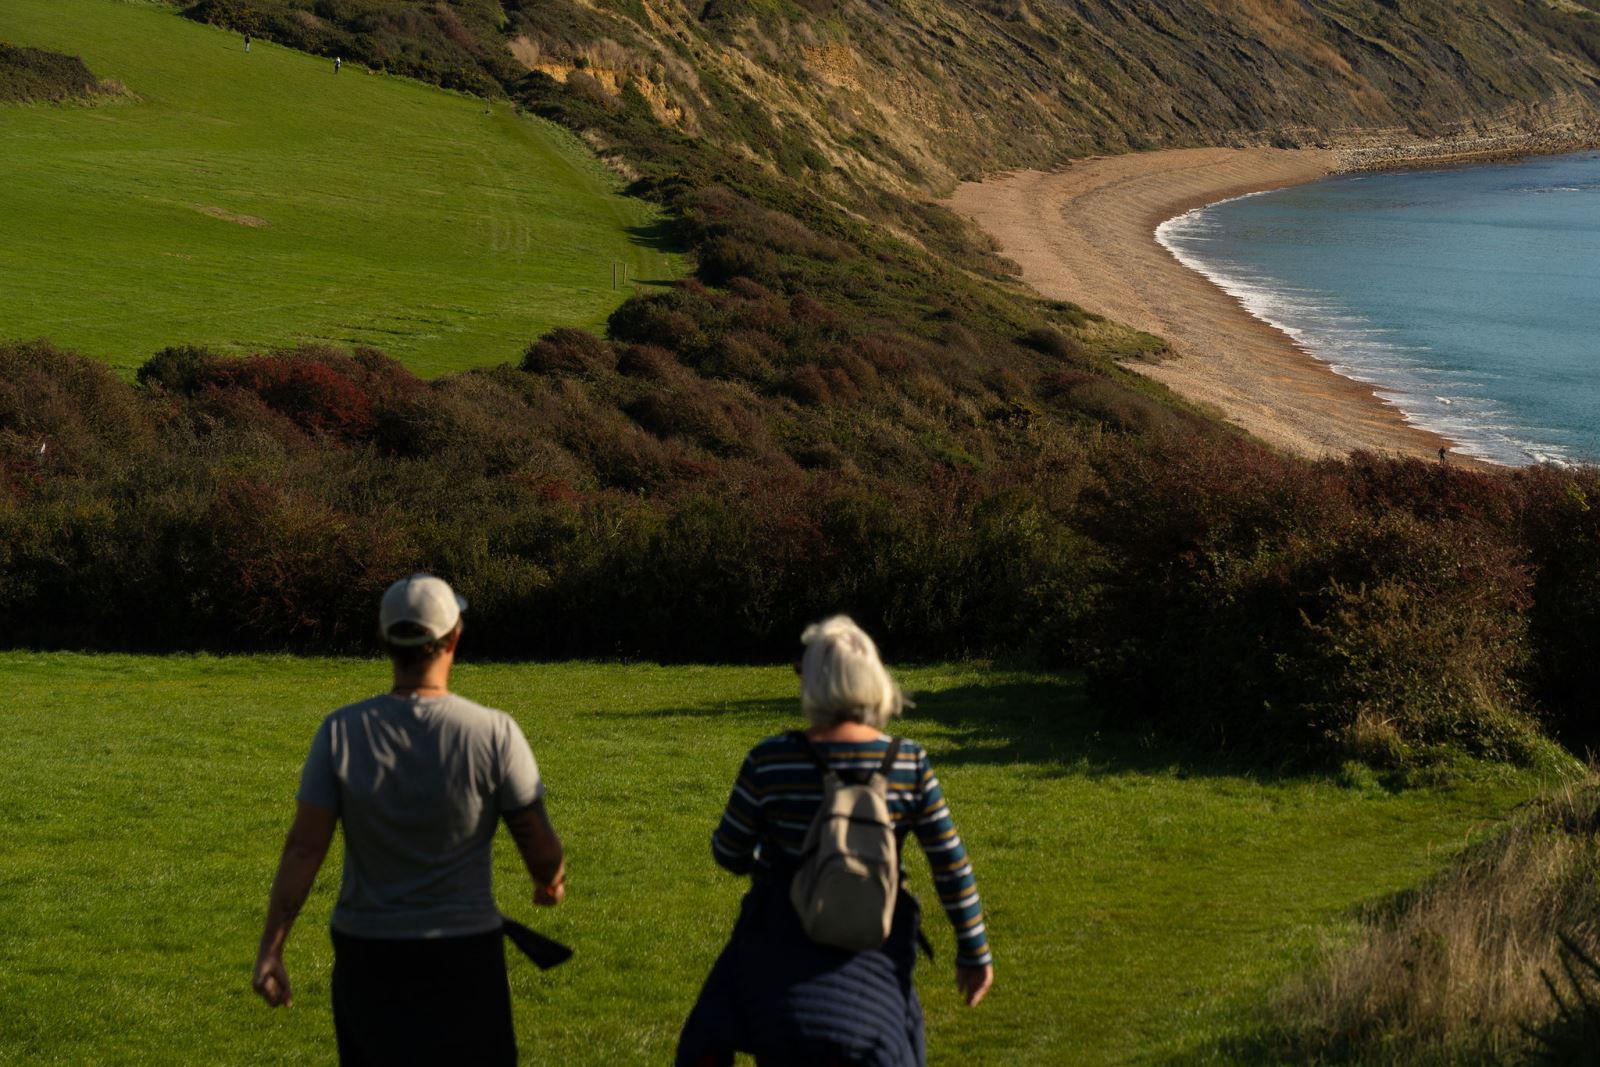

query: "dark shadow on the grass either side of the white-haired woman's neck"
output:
600 675 1285 781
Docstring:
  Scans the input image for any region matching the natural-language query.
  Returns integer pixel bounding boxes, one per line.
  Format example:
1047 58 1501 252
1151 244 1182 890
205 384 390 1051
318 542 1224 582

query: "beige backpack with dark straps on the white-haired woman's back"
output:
789 729 901 952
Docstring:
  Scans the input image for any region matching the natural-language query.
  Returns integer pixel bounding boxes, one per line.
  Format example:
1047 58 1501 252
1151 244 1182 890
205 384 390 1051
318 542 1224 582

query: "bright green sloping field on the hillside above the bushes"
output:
0 0 680 374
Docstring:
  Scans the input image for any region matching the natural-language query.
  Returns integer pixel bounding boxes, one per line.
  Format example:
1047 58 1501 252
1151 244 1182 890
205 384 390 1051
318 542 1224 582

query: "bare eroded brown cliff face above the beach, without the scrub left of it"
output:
668 0 1600 186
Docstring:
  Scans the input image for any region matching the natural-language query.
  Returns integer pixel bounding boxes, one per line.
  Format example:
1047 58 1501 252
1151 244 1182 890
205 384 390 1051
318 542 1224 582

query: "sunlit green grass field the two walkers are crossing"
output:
0 653 1541 1064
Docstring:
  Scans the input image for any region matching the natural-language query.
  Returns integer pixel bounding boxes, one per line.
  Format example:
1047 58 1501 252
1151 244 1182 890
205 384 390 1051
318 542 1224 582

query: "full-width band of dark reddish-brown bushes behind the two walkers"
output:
12 334 1600 766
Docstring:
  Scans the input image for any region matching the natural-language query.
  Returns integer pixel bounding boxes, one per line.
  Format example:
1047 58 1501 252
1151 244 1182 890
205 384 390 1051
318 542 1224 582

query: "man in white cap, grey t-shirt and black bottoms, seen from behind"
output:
251 574 566 1067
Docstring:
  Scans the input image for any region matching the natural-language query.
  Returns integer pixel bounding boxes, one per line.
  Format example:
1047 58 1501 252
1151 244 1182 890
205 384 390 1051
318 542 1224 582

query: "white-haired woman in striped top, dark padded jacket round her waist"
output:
677 616 994 1067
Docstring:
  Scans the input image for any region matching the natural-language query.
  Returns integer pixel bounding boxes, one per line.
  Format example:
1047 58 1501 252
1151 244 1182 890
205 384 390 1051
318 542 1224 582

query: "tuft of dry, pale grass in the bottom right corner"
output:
1277 774 1600 1064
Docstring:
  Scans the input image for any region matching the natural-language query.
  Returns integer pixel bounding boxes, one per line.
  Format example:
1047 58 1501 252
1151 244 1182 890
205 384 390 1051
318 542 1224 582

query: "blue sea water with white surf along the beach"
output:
1157 152 1600 464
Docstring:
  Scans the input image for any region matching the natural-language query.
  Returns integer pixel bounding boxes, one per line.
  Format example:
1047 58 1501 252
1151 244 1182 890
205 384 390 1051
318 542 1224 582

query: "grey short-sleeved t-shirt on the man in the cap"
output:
299 694 544 937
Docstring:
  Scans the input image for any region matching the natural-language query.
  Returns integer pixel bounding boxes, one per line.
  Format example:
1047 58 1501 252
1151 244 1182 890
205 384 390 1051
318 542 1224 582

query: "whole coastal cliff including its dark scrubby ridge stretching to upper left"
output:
187 0 1600 194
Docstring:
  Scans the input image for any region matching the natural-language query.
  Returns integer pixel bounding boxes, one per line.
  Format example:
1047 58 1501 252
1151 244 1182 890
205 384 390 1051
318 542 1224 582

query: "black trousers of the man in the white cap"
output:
333 929 517 1067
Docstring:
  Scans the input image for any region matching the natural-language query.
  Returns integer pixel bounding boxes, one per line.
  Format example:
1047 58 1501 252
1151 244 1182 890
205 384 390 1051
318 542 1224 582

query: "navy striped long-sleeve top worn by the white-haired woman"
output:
710 734 990 966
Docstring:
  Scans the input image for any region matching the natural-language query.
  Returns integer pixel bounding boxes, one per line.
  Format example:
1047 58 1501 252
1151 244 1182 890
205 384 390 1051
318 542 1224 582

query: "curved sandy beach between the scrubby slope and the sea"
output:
950 149 1450 456
